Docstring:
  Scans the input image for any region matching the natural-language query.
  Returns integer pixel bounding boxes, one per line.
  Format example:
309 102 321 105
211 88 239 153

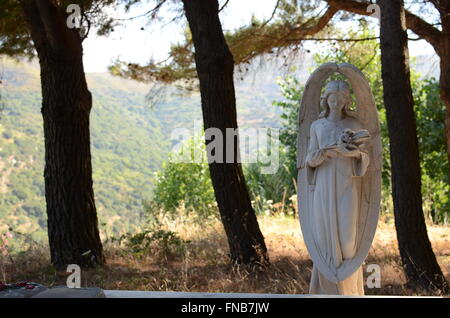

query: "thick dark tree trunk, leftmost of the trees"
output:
22 0 105 269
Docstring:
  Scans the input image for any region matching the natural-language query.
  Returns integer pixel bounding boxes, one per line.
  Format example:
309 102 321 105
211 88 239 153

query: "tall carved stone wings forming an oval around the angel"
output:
297 62 382 283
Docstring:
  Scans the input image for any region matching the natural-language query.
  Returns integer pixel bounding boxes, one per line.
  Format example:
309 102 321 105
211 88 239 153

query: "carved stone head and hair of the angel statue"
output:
320 81 352 117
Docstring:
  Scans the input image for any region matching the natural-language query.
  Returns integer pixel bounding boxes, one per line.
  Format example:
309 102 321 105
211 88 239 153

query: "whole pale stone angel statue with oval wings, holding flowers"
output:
297 63 382 295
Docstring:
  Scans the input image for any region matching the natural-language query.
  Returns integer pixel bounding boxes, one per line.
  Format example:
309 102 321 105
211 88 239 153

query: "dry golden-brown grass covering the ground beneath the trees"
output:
0 216 450 295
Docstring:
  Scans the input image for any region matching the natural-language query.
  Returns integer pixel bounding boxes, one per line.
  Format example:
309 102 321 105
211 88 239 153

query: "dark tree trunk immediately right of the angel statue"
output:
377 0 447 292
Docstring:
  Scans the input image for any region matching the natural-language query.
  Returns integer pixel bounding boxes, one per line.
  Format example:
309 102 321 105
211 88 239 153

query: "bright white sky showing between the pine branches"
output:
83 0 435 72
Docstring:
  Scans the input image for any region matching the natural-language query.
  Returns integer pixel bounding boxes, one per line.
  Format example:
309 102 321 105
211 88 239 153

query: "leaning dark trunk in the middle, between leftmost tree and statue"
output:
183 0 268 264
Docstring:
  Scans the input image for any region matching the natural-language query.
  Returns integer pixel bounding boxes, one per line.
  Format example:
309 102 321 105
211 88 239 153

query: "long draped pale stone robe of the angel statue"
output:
306 116 369 295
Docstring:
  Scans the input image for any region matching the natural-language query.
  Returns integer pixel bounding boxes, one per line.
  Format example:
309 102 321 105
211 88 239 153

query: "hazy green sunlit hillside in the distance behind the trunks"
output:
0 59 280 239
